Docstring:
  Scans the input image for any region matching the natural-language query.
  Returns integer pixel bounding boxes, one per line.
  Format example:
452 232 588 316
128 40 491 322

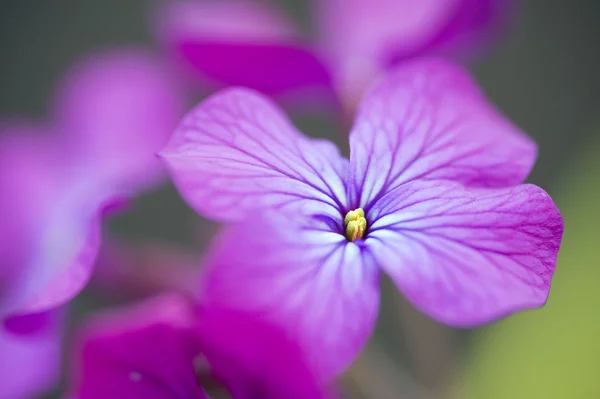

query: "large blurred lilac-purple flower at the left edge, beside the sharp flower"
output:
0 50 183 326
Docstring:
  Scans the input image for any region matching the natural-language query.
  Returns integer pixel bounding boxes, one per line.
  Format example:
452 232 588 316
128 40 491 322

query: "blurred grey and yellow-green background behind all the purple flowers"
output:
0 0 600 399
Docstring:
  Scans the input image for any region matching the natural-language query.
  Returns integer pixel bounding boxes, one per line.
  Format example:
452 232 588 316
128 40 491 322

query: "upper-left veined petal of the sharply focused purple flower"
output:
161 88 348 221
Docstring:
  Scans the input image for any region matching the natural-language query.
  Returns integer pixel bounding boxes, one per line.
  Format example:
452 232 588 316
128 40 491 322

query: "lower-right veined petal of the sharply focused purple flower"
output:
366 181 563 327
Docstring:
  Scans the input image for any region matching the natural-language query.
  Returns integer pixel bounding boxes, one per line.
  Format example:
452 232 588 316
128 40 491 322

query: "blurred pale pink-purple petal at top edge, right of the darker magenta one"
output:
317 0 460 101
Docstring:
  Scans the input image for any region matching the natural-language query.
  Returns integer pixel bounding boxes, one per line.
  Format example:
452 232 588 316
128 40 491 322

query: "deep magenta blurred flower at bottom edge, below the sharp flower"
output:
70 294 325 399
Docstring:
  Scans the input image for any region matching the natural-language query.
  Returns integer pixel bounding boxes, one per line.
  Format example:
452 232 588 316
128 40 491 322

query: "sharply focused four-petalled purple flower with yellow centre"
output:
161 59 563 379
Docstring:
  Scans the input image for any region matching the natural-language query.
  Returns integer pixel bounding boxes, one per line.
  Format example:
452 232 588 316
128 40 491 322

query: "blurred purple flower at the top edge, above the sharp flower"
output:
157 0 510 114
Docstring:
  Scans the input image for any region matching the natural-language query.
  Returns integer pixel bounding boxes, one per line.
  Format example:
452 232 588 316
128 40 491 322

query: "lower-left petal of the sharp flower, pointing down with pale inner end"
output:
202 215 379 381
